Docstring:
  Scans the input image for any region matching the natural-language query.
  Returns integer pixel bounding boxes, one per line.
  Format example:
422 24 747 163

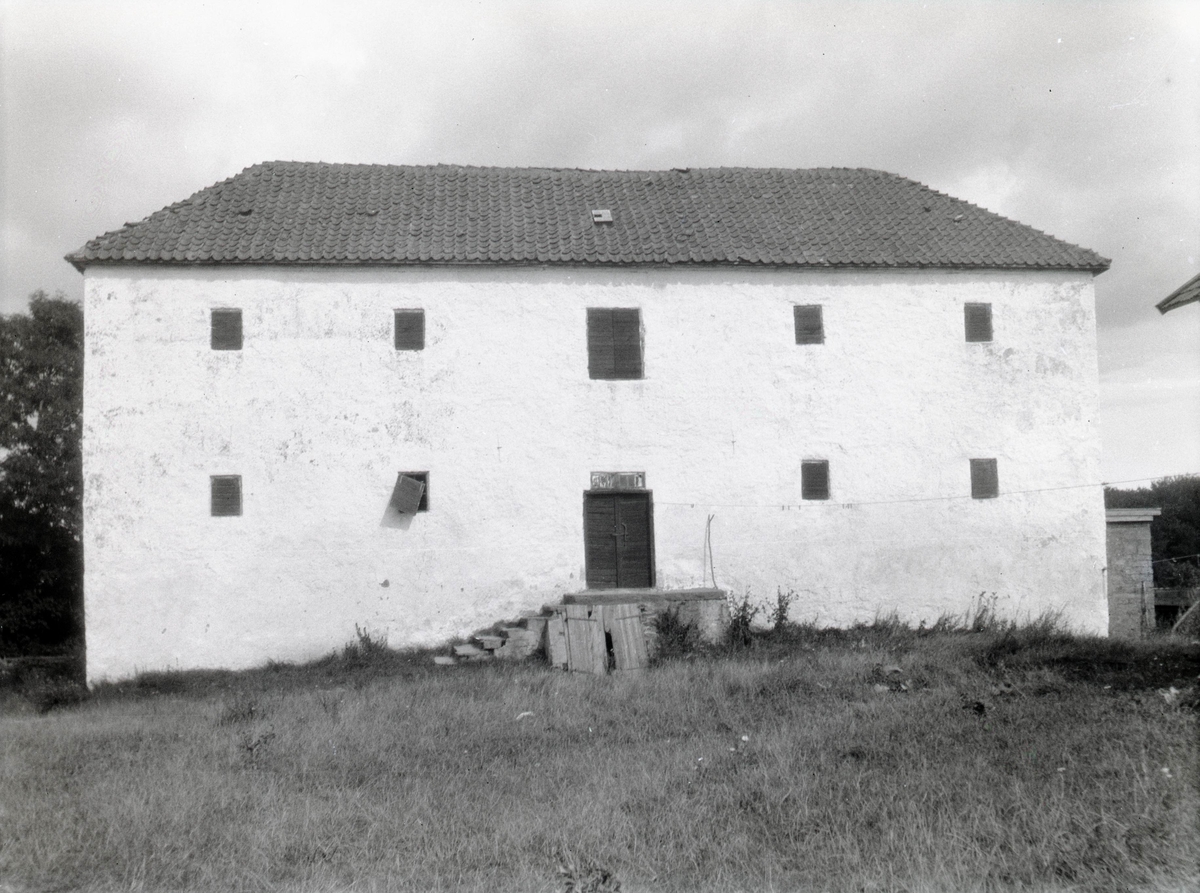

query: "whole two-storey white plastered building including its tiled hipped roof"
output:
68 162 1108 682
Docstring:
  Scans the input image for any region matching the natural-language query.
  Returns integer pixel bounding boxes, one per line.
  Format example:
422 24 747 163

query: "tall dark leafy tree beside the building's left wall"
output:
0 290 83 655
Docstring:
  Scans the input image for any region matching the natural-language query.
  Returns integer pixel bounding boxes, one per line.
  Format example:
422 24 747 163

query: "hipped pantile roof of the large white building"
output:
67 161 1109 272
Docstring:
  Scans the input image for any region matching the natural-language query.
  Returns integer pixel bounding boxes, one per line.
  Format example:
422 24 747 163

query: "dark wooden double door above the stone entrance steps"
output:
583 493 654 589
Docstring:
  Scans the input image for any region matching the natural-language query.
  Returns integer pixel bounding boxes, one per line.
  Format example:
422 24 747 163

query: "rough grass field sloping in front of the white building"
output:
0 623 1200 893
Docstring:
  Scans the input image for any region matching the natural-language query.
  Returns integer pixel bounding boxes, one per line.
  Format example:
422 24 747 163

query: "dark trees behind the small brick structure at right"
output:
1104 474 1200 588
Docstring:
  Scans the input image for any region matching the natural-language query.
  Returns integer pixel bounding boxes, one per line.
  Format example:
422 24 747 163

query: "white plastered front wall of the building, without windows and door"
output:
84 261 1106 681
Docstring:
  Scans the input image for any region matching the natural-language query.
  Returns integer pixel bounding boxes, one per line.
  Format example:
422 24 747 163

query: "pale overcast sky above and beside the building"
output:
0 0 1200 481
